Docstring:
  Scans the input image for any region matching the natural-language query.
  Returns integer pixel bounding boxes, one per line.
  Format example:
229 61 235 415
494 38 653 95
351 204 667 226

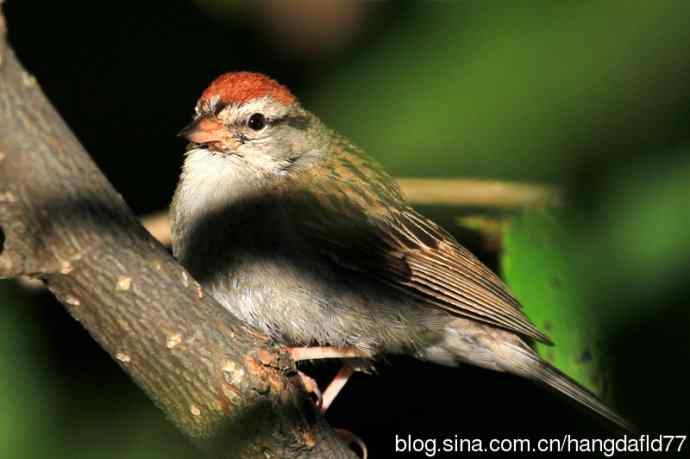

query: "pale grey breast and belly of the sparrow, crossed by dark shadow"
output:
171 151 426 352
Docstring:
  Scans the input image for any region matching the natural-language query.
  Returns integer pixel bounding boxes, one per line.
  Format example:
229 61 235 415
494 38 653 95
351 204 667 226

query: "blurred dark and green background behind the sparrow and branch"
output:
0 0 690 458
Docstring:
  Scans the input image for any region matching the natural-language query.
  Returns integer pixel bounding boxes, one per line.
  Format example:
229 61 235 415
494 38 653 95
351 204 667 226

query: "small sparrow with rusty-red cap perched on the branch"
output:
170 72 632 429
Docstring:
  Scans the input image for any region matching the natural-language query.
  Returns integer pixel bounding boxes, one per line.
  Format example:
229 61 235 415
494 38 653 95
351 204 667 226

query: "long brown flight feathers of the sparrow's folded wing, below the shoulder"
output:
310 202 551 343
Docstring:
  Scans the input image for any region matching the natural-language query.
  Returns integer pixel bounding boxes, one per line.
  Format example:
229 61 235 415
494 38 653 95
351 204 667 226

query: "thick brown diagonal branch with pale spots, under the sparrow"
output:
0 7 354 458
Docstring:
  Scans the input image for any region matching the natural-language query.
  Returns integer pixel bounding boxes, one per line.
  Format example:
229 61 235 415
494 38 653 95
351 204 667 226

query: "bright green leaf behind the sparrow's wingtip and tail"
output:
501 210 605 395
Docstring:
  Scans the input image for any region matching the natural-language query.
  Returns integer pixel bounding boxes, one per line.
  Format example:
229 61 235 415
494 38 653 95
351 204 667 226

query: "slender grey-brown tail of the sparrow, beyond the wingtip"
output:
537 361 638 432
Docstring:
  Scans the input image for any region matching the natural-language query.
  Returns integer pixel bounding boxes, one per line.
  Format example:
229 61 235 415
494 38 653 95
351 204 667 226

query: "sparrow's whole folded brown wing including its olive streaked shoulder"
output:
288 137 550 343
